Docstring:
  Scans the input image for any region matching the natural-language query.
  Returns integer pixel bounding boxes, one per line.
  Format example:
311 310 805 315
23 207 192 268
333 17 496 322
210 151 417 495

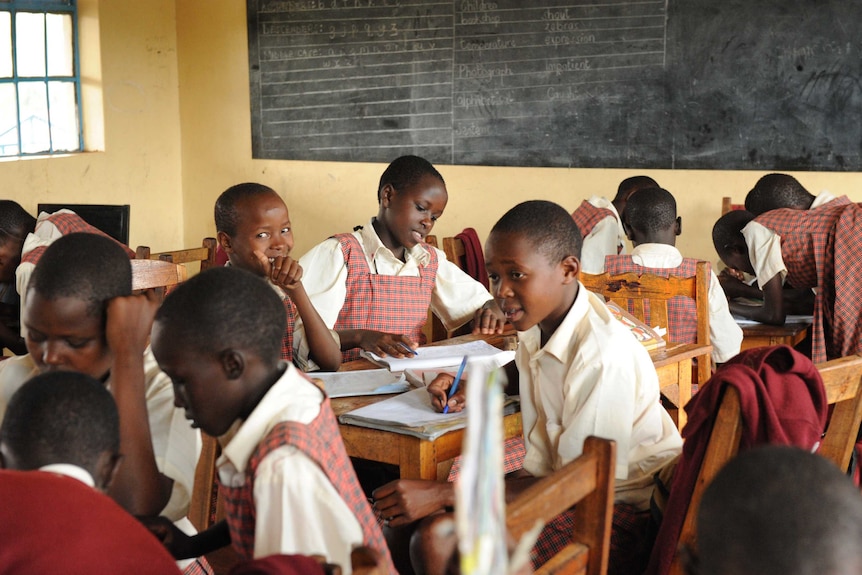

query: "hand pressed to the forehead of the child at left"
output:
105 290 159 357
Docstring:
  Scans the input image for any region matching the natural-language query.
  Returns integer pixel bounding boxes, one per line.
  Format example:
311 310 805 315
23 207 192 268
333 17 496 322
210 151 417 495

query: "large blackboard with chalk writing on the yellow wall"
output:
248 0 862 171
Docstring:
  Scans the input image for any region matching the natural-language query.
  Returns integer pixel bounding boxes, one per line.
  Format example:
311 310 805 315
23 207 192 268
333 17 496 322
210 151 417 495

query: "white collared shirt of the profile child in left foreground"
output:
217 364 364 575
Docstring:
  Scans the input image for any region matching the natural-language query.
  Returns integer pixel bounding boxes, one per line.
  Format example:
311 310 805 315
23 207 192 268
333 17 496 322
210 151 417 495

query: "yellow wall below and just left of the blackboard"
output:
177 0 862 266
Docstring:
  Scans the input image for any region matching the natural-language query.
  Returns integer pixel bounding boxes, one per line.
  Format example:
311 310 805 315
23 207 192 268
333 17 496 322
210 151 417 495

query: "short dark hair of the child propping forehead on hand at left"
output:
27 233 132 317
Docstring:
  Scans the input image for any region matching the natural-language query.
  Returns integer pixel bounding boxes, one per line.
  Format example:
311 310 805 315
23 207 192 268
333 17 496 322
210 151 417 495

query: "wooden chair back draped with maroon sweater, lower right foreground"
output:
670 355 862 575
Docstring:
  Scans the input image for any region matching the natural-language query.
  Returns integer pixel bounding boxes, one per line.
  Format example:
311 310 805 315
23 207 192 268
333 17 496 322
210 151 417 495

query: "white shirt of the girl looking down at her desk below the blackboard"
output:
297 218 493 336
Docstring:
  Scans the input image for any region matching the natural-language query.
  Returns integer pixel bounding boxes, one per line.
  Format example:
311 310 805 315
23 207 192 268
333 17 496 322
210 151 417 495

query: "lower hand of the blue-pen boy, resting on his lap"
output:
371 479 452 527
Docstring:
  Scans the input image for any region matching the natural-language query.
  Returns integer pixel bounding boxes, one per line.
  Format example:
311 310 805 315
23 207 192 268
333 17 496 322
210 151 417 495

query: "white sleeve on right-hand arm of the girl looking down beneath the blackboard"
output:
431 248 494 330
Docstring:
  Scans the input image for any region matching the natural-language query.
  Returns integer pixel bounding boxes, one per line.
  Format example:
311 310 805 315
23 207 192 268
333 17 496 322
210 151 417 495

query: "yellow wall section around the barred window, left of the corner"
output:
0 0 183 249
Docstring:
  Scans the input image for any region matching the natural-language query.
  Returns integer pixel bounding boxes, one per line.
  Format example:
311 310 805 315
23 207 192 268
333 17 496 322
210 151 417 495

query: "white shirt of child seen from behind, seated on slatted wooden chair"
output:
632 244 742 363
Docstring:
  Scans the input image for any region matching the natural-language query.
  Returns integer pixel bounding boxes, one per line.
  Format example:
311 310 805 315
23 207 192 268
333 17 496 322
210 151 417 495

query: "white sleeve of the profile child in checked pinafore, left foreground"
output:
254 446 363 573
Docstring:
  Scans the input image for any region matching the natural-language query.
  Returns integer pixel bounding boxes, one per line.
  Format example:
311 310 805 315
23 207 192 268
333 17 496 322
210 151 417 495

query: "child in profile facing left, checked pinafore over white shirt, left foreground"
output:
152 267 392 574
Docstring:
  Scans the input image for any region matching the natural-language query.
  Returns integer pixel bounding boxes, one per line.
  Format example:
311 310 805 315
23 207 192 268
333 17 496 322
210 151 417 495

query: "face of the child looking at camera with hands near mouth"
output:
218 193 293 275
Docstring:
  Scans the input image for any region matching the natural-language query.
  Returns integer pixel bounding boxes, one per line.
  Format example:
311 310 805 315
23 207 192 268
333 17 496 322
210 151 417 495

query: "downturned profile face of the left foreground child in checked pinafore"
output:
152 321 246 437
